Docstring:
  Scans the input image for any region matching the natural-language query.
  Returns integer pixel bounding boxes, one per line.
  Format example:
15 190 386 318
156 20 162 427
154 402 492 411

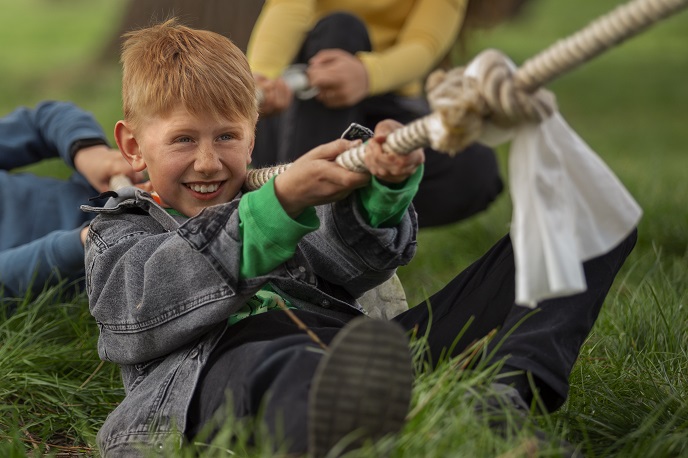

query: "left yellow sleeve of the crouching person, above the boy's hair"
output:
246 0 316 78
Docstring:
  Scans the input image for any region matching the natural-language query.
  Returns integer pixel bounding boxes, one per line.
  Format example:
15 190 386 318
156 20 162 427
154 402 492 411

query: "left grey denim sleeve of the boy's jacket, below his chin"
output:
86 203 266 364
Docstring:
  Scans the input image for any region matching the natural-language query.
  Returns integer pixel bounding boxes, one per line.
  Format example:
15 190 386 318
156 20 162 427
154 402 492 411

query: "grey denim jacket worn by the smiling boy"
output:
82 187 417 457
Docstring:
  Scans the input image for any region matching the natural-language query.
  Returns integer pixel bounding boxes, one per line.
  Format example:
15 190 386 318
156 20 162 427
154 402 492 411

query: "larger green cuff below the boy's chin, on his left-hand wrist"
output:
239 178 320 278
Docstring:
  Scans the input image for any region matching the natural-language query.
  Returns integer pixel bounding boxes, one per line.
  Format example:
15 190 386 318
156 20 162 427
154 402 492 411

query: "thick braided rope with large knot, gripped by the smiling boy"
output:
245 0 688 191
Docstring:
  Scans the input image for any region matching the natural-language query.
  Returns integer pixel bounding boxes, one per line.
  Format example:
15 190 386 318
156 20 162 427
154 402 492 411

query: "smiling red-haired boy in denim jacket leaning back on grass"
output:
83 16 635 457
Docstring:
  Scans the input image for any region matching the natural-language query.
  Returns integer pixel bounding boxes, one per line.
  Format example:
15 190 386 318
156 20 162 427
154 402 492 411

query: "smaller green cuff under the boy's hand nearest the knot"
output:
358 165 423 227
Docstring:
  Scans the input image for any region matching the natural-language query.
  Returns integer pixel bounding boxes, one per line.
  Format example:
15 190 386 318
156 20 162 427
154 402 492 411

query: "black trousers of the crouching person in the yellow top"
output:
253 13 503 227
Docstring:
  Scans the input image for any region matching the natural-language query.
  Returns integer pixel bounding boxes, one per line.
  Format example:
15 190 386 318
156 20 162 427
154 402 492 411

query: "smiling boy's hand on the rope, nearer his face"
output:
275 139 370 218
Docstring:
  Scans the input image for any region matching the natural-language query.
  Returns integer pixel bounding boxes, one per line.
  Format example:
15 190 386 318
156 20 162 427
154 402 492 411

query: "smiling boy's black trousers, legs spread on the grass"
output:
187 231 637 452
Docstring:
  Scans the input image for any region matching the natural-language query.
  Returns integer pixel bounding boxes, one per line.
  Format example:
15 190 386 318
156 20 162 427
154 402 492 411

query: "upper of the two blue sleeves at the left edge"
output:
0 101 107 170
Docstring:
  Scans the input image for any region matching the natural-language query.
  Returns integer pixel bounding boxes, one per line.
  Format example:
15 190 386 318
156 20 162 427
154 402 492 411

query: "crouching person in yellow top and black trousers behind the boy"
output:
247 0 503 227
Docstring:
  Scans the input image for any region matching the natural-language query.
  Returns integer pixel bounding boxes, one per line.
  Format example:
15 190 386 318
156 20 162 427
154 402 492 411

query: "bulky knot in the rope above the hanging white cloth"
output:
426 50 556 154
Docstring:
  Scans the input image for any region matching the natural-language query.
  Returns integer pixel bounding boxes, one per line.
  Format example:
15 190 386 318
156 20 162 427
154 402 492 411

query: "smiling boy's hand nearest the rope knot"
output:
363 119 425 183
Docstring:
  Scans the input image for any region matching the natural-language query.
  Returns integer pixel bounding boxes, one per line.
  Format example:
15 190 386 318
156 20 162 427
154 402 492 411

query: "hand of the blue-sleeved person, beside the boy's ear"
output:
74 145 144 192
